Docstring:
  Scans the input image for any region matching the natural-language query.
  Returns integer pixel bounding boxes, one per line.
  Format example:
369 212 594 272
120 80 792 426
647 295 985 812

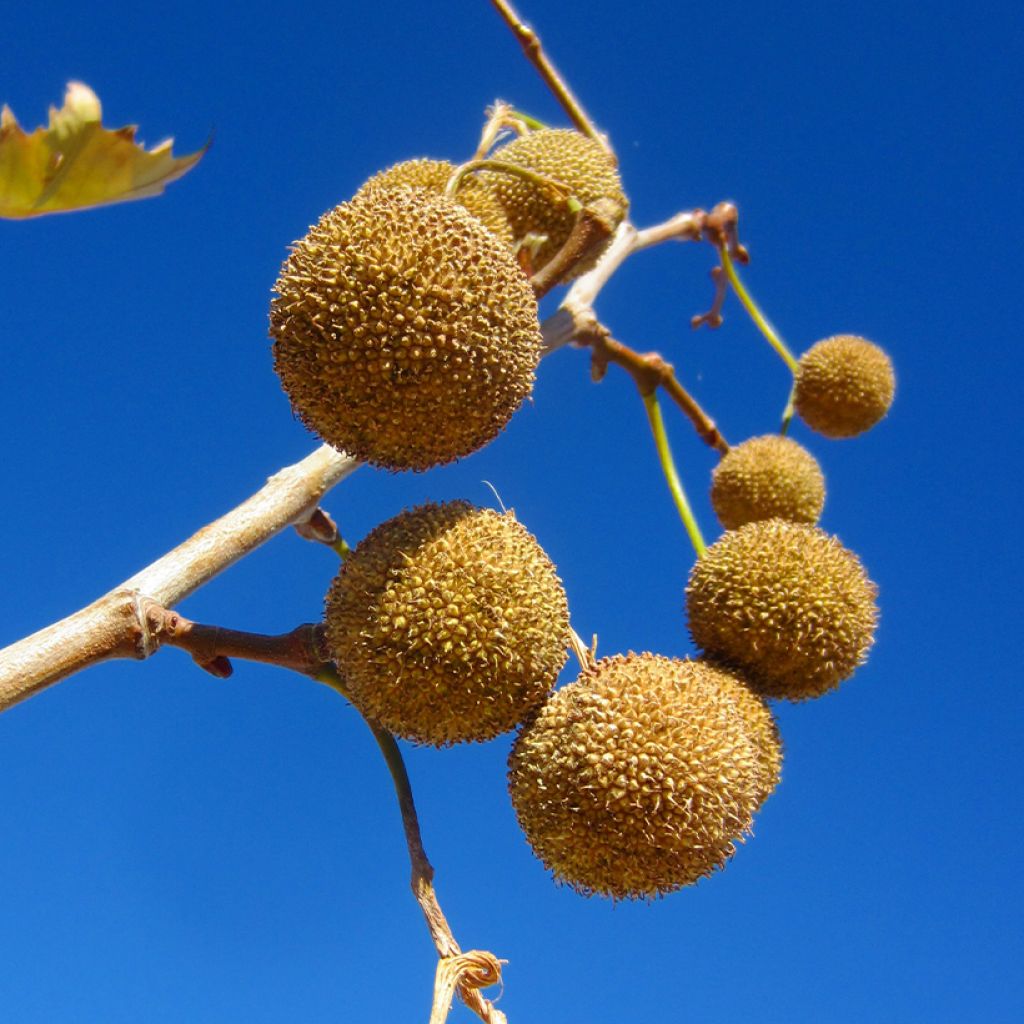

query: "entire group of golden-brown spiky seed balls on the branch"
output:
271 123 893 898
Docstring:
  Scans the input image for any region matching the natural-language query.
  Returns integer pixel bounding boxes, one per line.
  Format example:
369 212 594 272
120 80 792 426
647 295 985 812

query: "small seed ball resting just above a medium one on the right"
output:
711 434 825 529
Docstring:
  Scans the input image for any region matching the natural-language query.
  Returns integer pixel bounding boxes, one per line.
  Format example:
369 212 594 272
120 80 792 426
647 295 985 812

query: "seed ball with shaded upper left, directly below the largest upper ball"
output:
325 501 569 746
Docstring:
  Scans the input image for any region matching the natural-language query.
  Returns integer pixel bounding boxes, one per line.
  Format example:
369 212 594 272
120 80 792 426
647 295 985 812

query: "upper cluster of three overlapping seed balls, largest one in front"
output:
270 129 628 470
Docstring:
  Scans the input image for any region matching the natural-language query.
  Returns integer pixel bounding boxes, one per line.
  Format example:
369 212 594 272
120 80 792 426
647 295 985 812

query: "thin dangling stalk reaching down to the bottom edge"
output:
315 666 504 1024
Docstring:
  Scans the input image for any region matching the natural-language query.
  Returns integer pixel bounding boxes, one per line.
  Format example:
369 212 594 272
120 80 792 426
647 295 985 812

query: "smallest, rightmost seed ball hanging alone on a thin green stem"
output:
793 334 896 437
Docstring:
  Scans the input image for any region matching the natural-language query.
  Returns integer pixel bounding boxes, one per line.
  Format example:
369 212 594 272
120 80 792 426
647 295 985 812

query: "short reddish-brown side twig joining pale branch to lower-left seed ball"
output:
142 601 330 679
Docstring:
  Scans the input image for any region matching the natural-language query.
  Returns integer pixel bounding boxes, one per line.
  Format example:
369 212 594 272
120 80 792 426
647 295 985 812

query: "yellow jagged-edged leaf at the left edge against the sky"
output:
0 82 209 219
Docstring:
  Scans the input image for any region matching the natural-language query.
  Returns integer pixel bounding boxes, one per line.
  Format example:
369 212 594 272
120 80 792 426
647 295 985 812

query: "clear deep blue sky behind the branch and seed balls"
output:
0 0 1024 1024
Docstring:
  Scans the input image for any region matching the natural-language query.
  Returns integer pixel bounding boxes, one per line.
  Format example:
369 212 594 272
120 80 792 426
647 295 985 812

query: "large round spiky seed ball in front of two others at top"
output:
270 188 541 470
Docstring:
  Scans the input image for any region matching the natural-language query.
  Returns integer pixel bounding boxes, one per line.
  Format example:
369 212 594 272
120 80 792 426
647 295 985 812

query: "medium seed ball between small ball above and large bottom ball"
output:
686 519 878 700
